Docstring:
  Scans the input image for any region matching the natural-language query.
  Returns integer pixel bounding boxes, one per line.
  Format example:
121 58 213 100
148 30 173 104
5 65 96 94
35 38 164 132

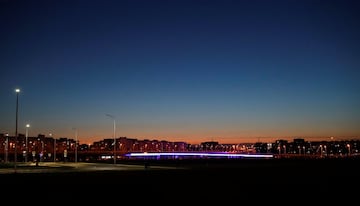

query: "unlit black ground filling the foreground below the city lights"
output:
0 158 360 205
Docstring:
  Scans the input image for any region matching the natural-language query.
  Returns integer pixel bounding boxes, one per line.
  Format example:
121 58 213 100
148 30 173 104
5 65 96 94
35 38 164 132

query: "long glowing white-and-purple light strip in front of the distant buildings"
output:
125 152 273 158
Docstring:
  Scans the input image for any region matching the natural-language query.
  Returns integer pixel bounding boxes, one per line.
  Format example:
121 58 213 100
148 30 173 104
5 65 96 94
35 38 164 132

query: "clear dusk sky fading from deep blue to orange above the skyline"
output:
0 0 360 143
